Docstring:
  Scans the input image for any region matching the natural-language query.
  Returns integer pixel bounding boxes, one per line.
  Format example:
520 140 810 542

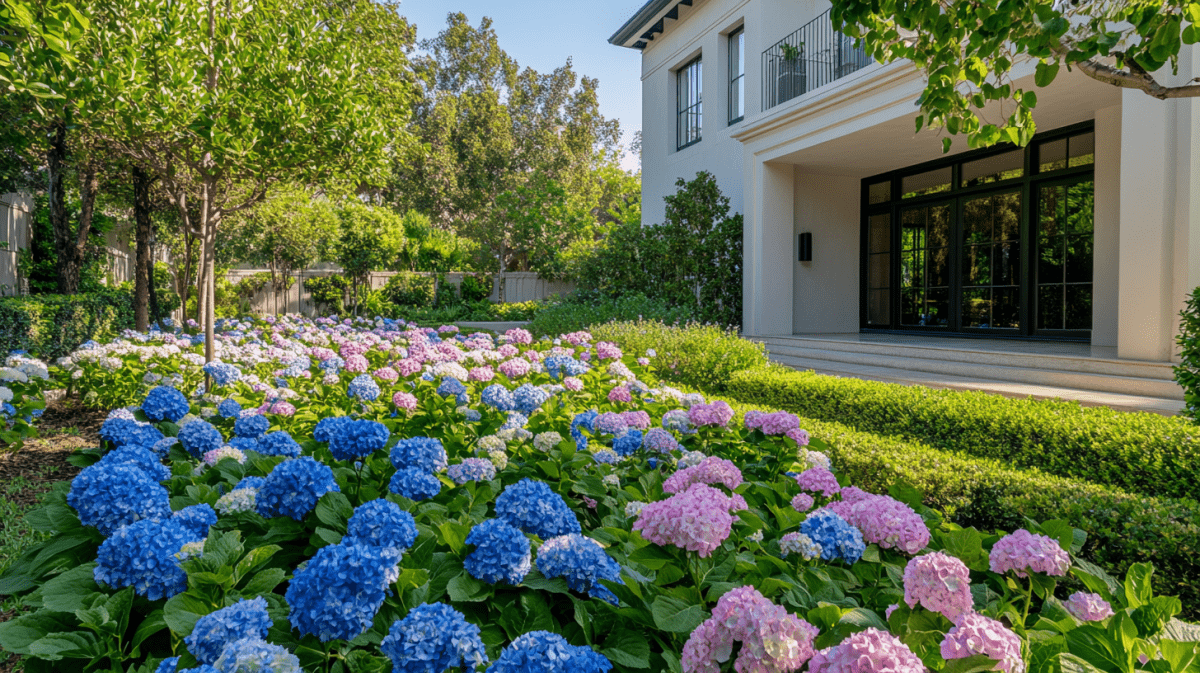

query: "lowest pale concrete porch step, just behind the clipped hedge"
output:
770 353 1183 416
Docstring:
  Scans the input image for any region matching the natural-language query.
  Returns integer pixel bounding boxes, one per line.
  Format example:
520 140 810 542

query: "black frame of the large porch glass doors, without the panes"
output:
859 121 1096 342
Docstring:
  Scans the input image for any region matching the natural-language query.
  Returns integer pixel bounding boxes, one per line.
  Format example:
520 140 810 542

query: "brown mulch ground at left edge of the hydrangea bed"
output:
0 401 106 673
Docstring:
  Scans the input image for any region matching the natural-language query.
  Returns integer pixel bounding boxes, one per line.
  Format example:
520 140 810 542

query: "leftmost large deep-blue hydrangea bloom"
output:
67 463 170 535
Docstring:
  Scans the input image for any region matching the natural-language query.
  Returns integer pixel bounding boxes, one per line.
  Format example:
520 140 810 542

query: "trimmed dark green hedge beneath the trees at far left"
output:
0 290 134 360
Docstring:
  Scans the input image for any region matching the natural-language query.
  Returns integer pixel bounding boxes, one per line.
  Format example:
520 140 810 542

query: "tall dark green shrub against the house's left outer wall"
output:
570 172 743 325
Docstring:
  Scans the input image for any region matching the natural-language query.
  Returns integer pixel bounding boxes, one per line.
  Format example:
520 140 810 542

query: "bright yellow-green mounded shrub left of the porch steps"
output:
590 320 767 390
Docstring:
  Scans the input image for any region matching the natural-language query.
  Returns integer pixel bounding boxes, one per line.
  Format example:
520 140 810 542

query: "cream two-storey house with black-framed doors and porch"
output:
610 0 1200 413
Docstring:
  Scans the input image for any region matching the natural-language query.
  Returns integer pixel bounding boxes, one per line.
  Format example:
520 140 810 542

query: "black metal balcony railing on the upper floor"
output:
762 11 875 110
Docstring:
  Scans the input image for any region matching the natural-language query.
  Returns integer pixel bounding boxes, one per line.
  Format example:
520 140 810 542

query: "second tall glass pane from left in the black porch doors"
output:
900 202 954 328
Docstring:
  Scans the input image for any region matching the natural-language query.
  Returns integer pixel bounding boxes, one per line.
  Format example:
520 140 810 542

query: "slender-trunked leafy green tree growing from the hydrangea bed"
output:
85 0 407 359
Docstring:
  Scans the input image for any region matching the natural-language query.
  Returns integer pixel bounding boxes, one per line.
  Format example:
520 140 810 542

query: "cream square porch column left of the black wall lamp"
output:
743 156 797 336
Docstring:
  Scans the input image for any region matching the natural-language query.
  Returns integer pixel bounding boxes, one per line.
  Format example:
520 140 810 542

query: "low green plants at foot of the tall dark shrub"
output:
529 290 695 335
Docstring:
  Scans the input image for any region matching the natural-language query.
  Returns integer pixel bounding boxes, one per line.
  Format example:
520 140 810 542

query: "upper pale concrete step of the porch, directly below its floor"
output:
753 342 1183 401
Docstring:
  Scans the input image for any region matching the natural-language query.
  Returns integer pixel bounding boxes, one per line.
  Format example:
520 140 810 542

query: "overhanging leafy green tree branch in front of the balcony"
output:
832 0 1200 151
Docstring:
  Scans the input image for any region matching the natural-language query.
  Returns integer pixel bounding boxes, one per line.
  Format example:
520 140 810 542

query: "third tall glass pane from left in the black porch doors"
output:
960 192 1021 330
